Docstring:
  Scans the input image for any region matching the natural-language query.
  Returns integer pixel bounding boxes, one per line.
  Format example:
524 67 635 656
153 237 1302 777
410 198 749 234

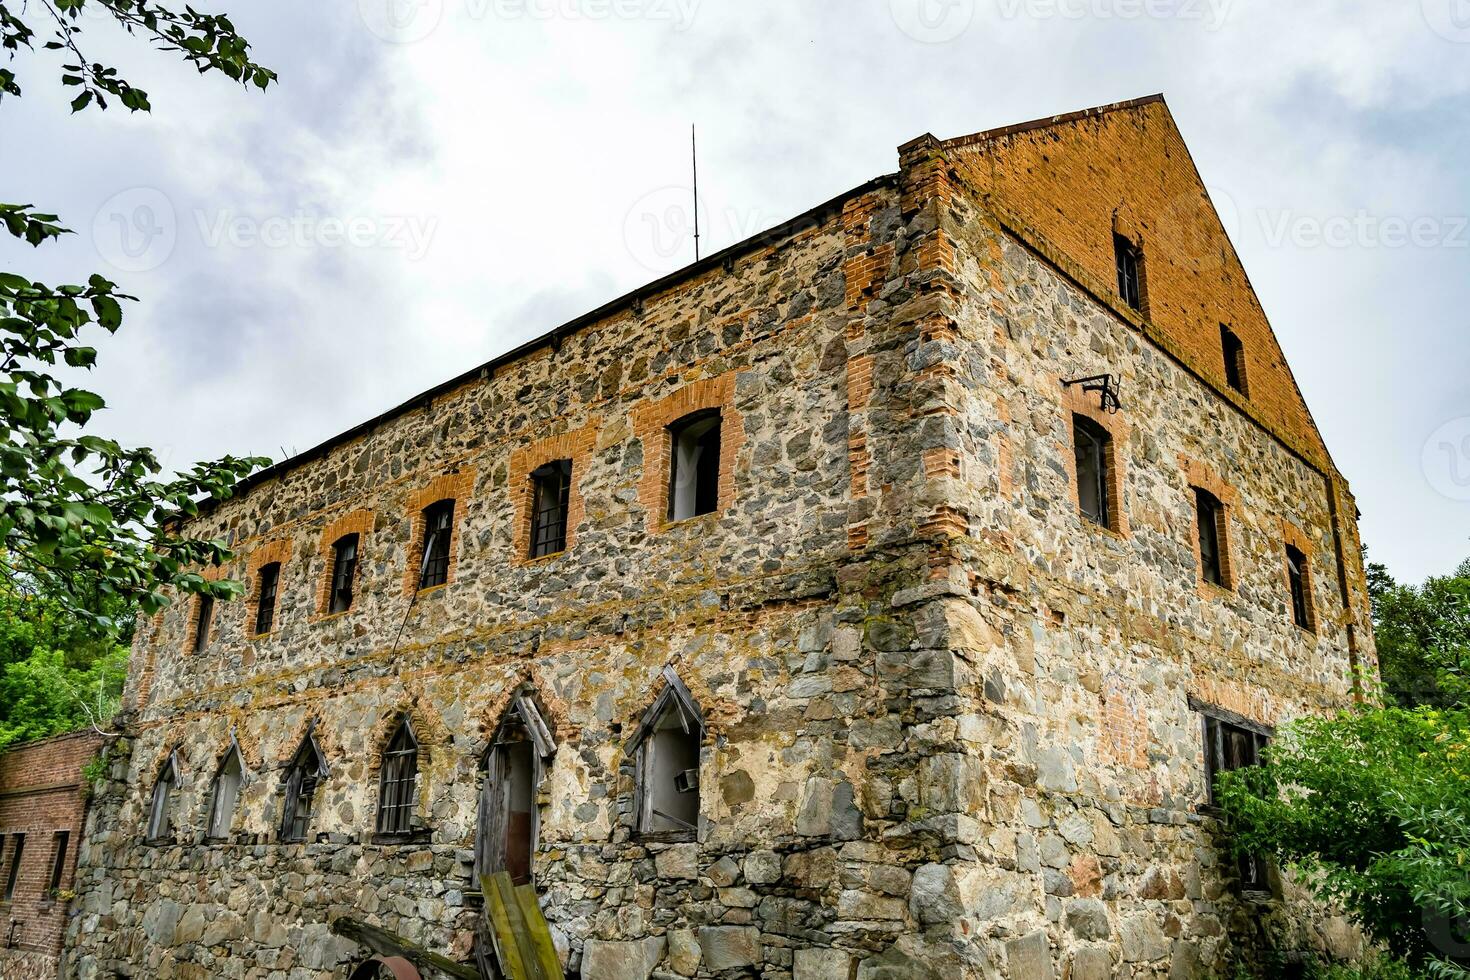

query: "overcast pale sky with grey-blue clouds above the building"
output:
0 0 1470 579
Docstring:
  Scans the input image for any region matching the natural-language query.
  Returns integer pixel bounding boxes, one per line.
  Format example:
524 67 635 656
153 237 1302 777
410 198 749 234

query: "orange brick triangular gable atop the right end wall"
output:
945 98 1329 476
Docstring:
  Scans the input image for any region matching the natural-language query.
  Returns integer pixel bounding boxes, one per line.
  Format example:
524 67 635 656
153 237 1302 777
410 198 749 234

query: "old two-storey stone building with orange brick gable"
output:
68 97 1376 980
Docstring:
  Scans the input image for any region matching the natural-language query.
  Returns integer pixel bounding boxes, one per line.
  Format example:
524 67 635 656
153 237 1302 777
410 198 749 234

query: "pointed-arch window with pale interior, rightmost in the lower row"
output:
632 667 704 840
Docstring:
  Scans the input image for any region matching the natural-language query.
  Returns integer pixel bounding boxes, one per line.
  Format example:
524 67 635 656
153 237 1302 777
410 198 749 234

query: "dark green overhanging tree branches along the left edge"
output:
0 0 275 632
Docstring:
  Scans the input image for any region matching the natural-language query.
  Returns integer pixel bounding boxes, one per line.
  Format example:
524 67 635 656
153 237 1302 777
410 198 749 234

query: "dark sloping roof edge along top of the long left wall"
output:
223 173 898 502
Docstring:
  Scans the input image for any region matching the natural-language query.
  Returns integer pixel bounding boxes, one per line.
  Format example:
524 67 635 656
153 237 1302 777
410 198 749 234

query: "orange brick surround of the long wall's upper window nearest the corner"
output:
631 370 745 530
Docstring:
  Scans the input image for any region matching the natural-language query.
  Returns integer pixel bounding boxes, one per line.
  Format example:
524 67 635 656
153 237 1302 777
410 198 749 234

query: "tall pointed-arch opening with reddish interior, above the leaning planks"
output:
475 691 556 884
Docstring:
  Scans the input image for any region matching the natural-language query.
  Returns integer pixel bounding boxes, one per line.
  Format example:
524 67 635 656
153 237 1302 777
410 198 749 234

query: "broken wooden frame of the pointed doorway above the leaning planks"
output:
475 686 557 883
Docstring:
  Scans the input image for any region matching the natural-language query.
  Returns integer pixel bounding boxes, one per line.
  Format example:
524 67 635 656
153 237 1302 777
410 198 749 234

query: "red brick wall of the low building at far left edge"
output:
0 732 104 980
